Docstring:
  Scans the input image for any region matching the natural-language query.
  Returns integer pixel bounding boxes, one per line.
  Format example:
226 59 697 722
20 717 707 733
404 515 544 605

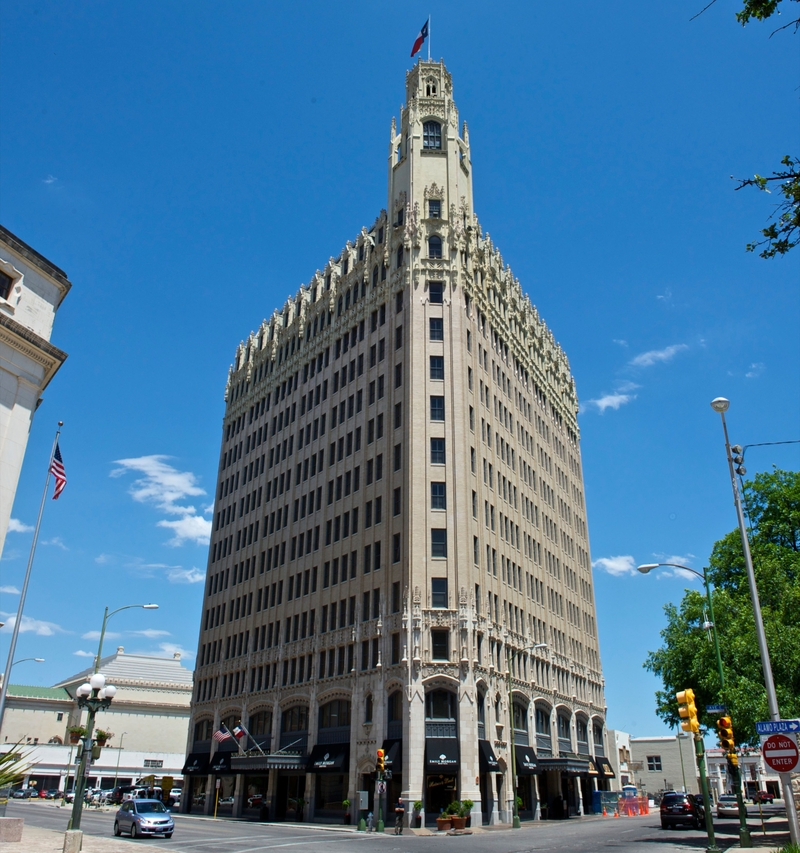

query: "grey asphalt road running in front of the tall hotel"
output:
7 801 785 853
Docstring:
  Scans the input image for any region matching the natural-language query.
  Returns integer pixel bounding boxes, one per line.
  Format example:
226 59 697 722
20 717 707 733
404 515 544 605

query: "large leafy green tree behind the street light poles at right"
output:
644 470 800 744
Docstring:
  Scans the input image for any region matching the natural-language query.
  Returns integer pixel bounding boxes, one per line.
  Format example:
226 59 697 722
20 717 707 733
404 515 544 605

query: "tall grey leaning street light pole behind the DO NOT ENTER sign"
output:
711 397 800 844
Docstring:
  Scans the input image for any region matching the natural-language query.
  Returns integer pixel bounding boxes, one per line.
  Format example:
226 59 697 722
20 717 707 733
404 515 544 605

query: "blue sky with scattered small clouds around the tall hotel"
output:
0 0 800 735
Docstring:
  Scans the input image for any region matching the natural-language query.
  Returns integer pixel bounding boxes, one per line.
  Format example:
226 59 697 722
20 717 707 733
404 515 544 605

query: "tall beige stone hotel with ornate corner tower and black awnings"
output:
183 61 613 823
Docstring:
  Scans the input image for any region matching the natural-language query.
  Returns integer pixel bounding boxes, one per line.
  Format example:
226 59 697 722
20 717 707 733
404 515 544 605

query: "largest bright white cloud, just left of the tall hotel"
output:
110 454 211 545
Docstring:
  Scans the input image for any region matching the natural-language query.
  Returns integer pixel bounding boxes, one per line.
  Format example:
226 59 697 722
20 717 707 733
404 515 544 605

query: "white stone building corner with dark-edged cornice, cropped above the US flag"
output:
0 225 72 555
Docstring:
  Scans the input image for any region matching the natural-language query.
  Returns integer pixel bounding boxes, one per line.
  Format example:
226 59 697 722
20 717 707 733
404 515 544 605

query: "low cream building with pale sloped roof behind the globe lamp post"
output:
0 646 192 790
